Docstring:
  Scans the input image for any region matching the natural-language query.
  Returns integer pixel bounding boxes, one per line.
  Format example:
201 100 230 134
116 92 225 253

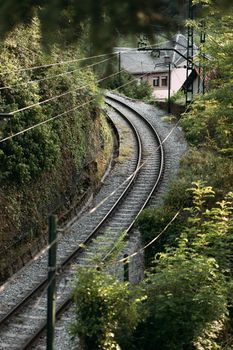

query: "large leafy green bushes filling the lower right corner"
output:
135 182 233 350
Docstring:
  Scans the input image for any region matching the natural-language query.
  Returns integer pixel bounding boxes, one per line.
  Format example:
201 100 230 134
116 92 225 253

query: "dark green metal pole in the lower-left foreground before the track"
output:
47 215 57 350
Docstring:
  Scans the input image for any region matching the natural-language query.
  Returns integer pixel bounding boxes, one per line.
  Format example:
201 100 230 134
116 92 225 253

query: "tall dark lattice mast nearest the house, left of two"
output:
186 0 194 105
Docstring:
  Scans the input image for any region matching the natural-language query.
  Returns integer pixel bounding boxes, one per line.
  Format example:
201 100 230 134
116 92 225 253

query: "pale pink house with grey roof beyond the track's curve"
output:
119 34 199 99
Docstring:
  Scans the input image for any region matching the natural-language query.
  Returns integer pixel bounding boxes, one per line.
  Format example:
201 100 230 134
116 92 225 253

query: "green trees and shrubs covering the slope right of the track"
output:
71 1 233 350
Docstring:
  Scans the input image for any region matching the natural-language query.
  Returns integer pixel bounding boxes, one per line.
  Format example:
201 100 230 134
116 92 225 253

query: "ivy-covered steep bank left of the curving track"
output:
0 18 112 282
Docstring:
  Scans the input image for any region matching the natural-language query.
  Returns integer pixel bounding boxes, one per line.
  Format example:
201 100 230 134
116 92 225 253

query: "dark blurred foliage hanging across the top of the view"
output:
0 0 186 51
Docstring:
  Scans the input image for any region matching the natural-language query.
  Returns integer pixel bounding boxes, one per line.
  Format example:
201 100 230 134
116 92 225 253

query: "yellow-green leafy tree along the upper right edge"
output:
182 8 233 158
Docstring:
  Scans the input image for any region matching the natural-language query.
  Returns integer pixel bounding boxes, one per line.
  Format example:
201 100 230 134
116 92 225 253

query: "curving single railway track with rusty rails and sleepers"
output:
0 91 164 350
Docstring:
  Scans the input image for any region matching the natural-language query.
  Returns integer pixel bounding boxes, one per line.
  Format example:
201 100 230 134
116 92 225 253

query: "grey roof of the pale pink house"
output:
116 34 197 74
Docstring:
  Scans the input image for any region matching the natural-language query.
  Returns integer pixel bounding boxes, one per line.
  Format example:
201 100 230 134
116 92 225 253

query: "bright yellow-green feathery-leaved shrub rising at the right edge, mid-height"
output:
184 182 233 276
